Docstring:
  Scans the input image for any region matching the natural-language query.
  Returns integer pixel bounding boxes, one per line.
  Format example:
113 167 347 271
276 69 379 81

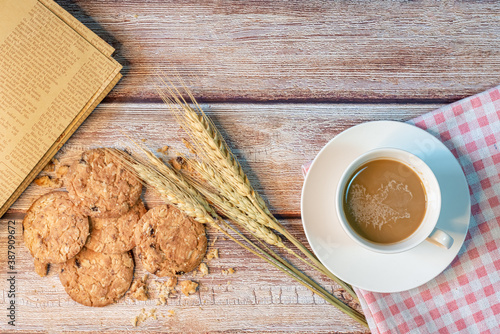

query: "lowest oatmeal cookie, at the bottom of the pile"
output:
59 247 134 307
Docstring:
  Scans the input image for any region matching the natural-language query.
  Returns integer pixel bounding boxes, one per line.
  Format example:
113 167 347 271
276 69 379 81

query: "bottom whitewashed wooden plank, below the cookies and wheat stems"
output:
0 215 367 333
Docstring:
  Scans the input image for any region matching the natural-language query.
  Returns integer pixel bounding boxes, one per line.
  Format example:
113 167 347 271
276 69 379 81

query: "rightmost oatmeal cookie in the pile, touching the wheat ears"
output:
135 205 207 277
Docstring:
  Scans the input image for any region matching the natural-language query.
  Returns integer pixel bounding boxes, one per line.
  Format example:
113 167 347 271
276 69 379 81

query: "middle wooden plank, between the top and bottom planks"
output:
8 103 438 217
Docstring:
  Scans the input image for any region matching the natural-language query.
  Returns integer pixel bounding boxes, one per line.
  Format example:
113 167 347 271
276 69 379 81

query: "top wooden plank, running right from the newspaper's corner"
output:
54 0 500 102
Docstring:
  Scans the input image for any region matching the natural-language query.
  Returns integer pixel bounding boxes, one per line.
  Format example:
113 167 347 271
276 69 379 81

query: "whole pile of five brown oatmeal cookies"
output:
23 149 207 306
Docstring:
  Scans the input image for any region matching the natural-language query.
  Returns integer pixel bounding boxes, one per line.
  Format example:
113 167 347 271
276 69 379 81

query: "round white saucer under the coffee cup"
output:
301 121 470 292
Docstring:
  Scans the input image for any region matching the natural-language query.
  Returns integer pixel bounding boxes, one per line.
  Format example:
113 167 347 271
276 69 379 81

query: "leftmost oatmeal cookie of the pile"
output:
23 191 89 263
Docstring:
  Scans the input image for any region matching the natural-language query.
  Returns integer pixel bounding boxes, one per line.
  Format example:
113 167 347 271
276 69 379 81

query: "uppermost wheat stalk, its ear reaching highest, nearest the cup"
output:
157 76 359 301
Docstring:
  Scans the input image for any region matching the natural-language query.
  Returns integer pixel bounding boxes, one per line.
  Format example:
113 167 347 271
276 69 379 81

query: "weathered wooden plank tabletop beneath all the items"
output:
0 0 500 333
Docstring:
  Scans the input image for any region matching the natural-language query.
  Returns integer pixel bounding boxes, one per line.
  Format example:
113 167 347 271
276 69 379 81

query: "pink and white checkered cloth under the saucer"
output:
303 86 500 334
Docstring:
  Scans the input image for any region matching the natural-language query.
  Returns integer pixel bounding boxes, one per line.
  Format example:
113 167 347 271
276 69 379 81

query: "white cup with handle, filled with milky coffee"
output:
336 148 453 253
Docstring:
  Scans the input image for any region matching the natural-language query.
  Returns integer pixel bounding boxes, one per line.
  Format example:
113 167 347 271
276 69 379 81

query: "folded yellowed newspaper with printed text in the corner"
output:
0 0 121 216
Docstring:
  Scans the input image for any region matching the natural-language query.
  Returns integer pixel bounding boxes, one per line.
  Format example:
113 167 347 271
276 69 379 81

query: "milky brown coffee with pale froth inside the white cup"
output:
343 158 427 244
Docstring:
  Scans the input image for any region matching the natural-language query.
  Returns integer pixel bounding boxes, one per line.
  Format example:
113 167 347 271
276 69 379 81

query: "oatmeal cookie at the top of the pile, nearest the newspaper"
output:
64 149 142 218
